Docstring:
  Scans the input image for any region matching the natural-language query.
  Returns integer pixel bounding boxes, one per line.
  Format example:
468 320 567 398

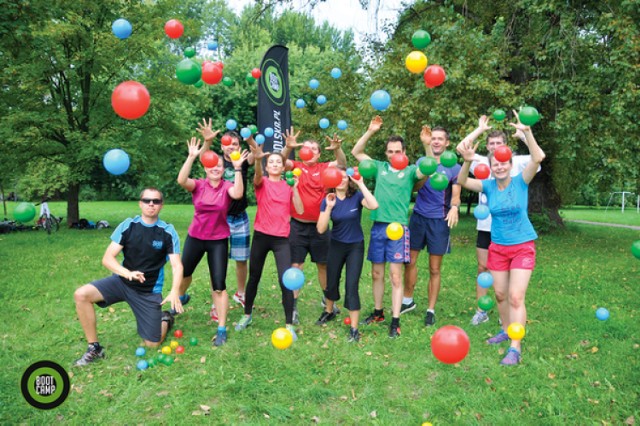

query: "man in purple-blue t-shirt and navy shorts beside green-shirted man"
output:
400 127 461 326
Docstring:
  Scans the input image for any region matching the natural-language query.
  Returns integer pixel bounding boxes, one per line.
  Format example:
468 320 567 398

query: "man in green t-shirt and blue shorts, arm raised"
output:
351 116 431 338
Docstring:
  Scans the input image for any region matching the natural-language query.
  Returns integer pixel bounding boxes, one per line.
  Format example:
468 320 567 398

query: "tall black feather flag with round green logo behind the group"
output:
258 45 291 152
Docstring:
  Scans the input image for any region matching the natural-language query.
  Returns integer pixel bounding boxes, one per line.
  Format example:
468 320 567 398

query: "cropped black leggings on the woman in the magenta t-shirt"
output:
182 235 229 291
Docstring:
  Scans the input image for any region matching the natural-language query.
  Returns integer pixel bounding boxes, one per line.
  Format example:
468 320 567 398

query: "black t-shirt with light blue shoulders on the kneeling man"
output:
111 216 180 293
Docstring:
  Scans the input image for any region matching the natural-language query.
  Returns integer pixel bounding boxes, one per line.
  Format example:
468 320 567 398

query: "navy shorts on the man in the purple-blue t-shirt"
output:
409 212 451 256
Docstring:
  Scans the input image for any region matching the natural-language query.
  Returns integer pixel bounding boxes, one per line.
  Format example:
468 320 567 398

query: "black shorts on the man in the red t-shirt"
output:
289 219 331 263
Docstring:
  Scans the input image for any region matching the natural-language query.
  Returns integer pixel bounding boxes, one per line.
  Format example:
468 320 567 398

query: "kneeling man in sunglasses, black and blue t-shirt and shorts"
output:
73 188 183 366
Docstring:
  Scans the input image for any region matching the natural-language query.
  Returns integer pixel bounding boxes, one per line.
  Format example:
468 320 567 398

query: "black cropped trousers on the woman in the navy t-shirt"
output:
324 239 364 311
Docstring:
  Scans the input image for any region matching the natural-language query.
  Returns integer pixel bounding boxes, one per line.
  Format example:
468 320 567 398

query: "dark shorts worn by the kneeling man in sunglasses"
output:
91 275 162 342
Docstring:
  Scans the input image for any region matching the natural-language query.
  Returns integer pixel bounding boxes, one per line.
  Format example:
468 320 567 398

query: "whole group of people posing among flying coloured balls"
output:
74 111 544 365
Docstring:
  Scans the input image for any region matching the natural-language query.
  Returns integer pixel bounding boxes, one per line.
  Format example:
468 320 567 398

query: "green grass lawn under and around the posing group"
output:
0 202 640 425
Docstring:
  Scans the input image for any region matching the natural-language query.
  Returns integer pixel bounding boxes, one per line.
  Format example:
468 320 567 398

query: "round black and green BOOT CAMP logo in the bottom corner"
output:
20 361 71 410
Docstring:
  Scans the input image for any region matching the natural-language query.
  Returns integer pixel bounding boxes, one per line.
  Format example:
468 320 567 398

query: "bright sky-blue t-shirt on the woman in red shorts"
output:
482 173 538 246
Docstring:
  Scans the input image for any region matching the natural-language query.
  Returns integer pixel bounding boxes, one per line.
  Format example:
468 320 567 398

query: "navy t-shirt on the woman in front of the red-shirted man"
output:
320 191 364 244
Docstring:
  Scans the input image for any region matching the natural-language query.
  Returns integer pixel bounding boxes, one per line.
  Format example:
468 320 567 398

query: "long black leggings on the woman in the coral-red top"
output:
244 230 293 324
